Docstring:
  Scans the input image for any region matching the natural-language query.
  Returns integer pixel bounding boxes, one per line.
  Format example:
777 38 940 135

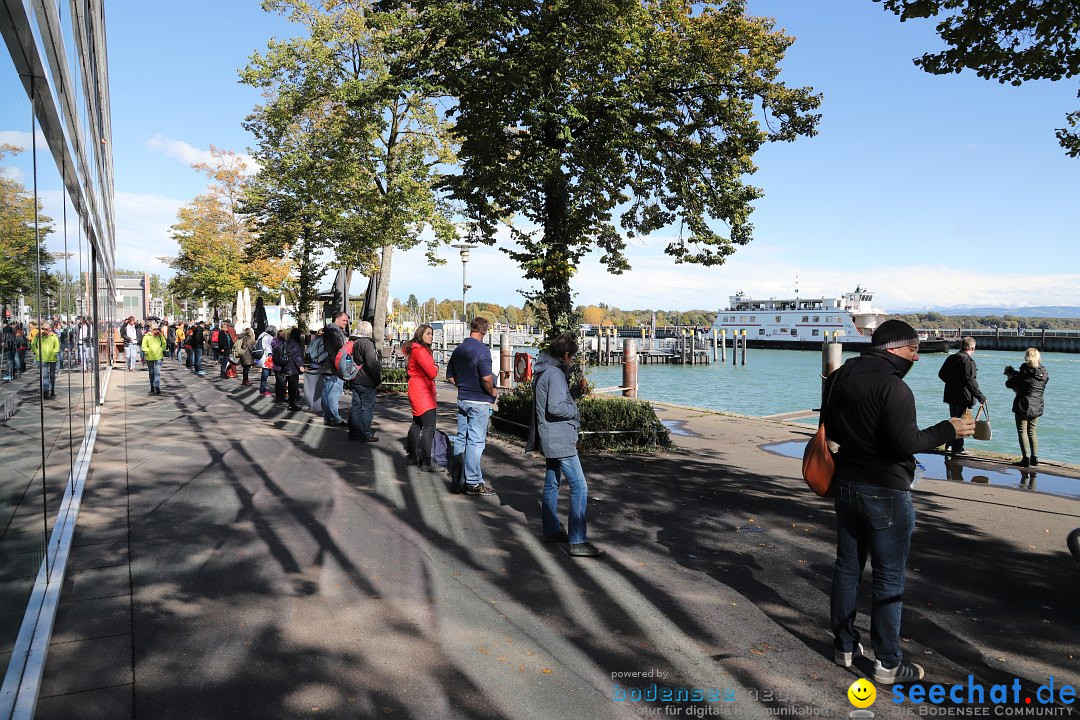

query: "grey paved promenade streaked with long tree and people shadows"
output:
29 361 1080 720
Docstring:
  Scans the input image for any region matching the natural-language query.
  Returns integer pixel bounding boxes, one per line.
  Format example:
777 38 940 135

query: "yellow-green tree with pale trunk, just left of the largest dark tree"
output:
241 0 456 338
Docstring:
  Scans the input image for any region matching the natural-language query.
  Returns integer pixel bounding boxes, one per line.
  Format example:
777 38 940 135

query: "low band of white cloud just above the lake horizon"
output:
378 237 1080 311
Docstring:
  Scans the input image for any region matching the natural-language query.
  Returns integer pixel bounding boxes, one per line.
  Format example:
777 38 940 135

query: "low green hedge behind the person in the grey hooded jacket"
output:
494 382 672 452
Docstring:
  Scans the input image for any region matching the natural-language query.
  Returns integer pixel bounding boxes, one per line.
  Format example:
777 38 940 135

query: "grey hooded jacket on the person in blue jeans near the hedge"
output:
525 353 581 458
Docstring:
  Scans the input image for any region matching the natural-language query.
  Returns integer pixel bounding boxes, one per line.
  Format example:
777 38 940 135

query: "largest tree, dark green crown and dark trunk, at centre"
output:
420 0 820 334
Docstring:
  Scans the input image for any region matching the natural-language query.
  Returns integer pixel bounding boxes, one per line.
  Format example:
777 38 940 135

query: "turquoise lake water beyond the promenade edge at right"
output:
589 348 1080 464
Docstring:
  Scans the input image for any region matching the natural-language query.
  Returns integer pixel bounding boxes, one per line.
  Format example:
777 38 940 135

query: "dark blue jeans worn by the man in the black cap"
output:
832 480 915 667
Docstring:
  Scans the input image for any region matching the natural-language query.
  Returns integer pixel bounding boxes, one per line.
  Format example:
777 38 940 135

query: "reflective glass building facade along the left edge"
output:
0 0 117 719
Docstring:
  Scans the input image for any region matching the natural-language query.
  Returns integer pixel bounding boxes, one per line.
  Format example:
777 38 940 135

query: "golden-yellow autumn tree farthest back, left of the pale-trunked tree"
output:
170 147 291 315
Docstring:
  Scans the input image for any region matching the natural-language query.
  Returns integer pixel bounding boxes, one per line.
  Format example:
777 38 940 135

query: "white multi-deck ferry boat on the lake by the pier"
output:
713 287 886 350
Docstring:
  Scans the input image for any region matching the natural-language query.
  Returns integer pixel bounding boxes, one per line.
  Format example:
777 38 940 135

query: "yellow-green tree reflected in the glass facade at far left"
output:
0 145 58 317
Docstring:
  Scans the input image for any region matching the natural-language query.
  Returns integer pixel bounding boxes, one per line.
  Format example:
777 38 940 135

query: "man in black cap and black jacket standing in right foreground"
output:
822 320 975 684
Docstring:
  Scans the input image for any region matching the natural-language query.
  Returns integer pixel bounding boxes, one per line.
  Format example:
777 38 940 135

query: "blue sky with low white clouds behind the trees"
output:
0 0 1080 309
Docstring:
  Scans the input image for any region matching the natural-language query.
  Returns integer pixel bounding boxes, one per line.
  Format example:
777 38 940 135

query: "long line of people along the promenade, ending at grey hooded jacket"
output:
99 312 604 557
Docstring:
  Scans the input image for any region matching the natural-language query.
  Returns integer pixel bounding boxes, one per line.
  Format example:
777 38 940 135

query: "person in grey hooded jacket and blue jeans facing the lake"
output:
526 335 604 557
